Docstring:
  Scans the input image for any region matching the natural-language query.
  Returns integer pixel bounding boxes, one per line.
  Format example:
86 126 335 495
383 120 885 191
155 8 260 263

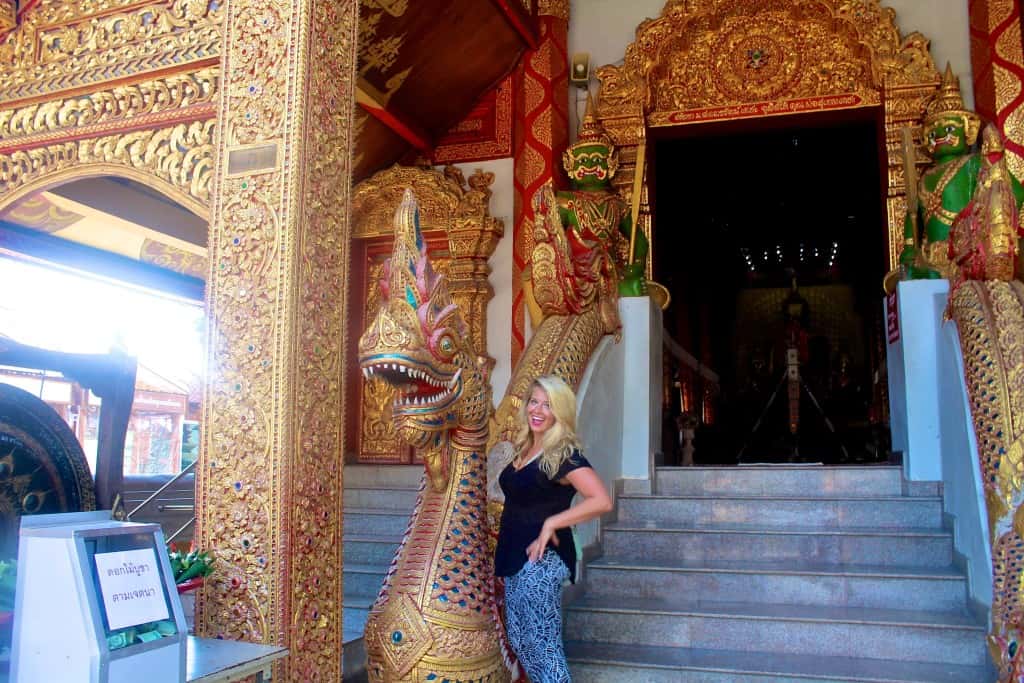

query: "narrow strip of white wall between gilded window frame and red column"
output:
438 158 514 408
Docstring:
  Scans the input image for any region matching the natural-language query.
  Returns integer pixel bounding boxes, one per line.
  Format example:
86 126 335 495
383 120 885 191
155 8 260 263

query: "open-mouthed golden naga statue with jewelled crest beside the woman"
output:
358 190 510 683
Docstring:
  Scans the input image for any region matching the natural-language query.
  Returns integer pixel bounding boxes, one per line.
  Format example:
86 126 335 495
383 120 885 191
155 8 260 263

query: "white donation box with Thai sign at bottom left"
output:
11 511 188 683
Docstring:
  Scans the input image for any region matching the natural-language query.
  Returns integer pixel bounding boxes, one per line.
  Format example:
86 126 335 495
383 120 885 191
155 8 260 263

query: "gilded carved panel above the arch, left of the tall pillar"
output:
0 0 222 216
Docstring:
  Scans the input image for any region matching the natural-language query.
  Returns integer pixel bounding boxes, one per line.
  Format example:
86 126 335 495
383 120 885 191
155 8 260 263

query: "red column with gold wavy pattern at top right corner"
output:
968 0 1024 178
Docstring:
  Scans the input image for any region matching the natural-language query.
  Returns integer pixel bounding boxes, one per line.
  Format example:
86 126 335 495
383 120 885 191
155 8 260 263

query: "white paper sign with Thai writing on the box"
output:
95 548 169 631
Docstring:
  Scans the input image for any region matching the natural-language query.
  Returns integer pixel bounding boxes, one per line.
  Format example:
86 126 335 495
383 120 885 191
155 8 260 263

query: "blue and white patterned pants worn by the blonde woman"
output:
505 550 572 683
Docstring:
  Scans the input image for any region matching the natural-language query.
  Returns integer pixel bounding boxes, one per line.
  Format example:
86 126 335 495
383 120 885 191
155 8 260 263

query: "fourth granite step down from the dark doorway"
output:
585 553 967 612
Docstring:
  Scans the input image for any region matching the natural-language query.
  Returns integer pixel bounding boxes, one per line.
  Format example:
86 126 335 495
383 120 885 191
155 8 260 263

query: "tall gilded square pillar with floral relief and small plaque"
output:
197 0 358 681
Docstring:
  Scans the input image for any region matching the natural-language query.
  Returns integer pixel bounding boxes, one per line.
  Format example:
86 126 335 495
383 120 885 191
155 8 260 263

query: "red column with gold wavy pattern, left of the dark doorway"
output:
512 0 569 368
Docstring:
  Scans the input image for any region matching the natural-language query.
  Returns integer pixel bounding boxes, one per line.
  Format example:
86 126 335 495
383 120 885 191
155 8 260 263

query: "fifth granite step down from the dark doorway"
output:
564 593 988 667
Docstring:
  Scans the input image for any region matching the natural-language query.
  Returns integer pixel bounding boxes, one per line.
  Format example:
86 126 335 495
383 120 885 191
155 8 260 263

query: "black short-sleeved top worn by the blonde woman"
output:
495 450 590 583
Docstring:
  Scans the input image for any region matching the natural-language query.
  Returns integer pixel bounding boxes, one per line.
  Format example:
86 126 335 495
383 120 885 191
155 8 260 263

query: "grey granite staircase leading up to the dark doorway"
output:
565 466 994 683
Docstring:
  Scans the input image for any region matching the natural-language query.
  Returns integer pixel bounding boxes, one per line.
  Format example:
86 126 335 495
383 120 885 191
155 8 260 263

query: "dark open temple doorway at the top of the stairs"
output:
649 110 889 465
